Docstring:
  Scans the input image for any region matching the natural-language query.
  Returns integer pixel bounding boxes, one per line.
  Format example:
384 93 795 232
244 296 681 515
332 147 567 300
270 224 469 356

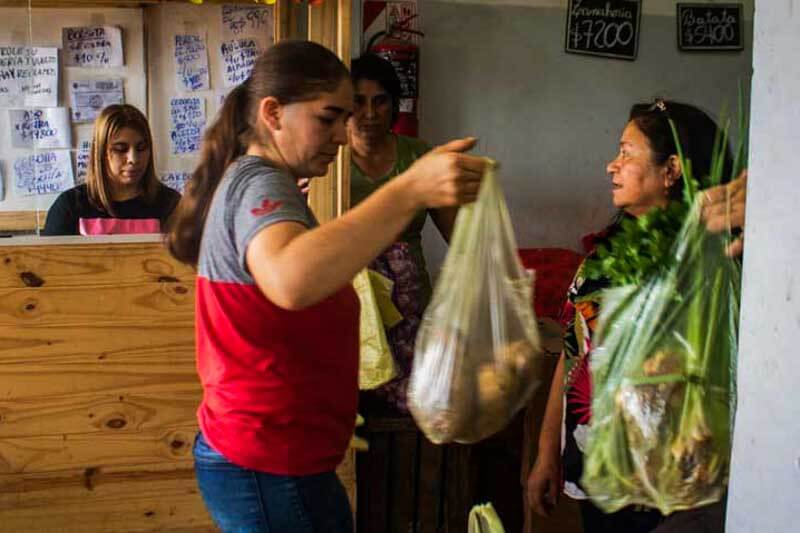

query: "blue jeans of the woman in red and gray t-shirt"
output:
193 433 353 533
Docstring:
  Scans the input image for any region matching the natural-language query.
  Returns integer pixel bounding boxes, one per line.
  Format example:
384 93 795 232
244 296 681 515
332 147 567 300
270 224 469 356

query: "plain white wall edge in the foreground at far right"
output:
727 0 800 533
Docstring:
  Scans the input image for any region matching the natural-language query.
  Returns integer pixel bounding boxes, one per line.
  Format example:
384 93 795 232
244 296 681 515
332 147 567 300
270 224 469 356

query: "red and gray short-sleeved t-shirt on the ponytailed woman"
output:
196 156 359 475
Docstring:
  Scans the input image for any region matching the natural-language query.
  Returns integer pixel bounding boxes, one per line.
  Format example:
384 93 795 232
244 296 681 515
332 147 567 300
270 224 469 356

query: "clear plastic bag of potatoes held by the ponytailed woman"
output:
408 160 542 443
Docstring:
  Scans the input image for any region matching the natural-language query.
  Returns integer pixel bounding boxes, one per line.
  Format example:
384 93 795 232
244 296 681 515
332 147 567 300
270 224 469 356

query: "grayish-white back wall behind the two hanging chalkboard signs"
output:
420 0 753 271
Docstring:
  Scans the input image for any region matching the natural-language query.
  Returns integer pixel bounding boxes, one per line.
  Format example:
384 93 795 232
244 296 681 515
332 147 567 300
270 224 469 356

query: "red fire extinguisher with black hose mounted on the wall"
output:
367 15 425 137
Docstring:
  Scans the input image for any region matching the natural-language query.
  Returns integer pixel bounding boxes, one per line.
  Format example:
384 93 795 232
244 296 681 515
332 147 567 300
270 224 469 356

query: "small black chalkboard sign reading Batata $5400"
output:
677 4 744 50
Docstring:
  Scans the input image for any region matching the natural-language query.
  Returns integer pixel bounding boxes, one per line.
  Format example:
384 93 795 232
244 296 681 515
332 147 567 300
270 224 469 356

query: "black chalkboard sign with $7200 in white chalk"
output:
566 0 642 60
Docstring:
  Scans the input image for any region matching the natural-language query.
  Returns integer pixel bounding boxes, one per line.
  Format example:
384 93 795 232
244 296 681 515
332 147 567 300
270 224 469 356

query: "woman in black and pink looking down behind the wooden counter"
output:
42 104 180 235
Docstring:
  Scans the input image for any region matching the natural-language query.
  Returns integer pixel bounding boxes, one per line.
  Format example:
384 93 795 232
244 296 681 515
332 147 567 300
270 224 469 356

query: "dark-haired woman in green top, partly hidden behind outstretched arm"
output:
347 54 458 414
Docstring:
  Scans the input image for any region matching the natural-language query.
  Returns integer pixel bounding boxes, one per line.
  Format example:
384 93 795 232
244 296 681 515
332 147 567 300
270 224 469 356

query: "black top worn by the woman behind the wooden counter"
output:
42 184 181 235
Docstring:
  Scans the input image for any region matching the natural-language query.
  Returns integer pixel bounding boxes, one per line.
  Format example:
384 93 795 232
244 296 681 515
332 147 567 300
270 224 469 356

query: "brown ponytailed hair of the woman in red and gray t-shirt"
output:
166 41 350 265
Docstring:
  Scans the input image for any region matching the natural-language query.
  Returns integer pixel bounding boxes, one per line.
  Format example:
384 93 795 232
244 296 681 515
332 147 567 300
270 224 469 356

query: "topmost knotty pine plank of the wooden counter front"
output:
0 243 195 287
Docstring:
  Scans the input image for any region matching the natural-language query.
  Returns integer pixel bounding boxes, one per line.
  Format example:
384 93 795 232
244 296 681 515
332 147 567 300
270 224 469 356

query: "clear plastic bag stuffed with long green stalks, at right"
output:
581 198 741 514
